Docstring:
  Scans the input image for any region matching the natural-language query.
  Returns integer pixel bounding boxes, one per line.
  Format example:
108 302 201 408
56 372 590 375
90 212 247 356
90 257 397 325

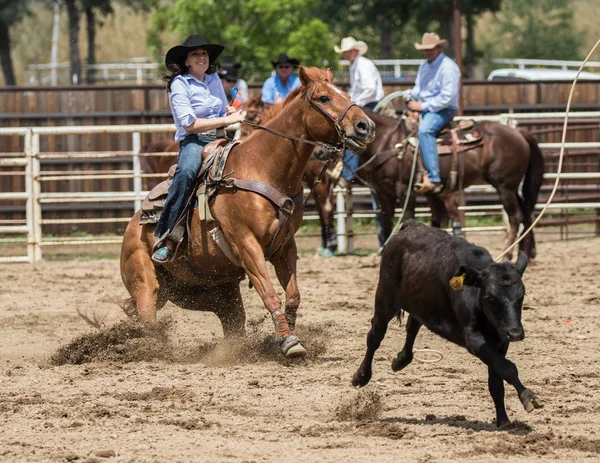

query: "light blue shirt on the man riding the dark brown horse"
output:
410 53 460 113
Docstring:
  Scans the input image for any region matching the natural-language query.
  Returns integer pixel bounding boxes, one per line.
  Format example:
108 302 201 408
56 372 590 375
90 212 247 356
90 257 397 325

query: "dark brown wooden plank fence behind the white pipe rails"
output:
0 81 600 237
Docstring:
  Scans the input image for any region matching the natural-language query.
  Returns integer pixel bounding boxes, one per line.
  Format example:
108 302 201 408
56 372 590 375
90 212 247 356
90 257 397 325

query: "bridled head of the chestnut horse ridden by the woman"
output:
299 66 375 151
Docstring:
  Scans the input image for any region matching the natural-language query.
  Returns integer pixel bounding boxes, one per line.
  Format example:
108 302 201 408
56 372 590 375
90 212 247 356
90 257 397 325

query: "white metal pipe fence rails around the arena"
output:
0 112 600 263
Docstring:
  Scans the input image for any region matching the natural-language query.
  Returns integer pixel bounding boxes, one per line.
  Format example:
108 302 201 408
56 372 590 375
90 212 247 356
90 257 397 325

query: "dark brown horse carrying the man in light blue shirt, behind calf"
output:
358 109 544 260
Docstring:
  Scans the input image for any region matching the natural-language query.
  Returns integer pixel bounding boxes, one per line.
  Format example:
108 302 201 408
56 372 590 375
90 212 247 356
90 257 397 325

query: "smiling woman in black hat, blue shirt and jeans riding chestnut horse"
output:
152 35 244 264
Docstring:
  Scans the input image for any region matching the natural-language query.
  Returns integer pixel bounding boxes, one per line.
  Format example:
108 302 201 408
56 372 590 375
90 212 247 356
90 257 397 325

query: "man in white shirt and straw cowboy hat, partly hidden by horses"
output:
333 37 383 248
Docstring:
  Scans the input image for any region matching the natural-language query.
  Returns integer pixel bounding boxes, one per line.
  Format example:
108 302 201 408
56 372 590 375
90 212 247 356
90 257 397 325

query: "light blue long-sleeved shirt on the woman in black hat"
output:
169 74 227 141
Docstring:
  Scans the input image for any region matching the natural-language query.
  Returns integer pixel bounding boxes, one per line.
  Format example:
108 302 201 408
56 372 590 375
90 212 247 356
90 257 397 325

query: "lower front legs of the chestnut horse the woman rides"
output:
238 239 306 358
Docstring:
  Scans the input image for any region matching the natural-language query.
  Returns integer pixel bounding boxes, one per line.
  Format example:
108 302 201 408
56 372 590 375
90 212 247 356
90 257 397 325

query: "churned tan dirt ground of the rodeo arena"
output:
0 237 600 462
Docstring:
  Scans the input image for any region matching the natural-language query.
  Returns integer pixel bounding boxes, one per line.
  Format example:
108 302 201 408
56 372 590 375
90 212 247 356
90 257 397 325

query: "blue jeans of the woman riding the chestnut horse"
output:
154 134 214 236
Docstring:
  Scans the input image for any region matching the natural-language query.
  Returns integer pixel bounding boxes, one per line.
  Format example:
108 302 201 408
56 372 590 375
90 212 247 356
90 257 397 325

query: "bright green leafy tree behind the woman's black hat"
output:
148 0 338 77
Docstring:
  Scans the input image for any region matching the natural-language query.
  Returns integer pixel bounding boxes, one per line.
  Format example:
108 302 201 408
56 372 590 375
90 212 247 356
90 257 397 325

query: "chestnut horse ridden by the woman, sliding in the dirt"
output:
121 67 374 357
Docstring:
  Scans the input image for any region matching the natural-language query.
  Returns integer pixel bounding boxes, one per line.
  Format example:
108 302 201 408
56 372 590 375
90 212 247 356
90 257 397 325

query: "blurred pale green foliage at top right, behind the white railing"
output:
478 0 582 60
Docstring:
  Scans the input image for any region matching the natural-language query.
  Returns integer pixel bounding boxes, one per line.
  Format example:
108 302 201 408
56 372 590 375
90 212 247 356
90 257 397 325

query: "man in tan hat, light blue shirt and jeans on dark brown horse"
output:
404 32 460 194
